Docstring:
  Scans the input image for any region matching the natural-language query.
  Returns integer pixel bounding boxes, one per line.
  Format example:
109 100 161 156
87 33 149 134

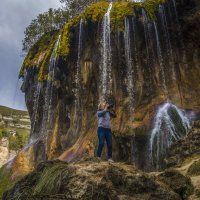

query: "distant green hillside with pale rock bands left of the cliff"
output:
0 106 31 167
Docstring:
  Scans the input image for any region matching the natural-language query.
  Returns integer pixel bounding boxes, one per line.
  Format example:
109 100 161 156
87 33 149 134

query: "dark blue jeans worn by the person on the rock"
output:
97 127 112 159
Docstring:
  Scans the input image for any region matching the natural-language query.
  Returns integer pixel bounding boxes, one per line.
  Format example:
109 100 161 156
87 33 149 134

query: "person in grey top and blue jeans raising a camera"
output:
97 101 116 162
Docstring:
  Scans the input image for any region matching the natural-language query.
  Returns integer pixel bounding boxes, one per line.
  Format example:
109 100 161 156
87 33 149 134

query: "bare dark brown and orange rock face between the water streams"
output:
19 1 200 168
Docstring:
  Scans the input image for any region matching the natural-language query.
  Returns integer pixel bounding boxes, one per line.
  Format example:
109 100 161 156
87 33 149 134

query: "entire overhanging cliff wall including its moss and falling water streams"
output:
16 0 200 172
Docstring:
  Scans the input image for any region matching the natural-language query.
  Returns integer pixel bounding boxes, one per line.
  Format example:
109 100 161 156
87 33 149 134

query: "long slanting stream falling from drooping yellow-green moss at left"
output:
41 35 61 137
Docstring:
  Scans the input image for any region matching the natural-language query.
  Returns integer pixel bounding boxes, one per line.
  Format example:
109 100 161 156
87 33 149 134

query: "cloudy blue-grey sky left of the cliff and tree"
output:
0 0 60 110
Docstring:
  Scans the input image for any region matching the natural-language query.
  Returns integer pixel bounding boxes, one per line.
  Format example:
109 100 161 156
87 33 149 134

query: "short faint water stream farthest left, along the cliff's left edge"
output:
31 83 42 135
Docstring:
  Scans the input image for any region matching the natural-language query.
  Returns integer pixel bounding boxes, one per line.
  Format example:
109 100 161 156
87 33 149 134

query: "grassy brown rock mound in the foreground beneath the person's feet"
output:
3 158 193 200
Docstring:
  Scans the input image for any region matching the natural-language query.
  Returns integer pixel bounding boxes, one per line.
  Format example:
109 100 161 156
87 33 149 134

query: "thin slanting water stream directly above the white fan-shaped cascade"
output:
153 22 168 96
